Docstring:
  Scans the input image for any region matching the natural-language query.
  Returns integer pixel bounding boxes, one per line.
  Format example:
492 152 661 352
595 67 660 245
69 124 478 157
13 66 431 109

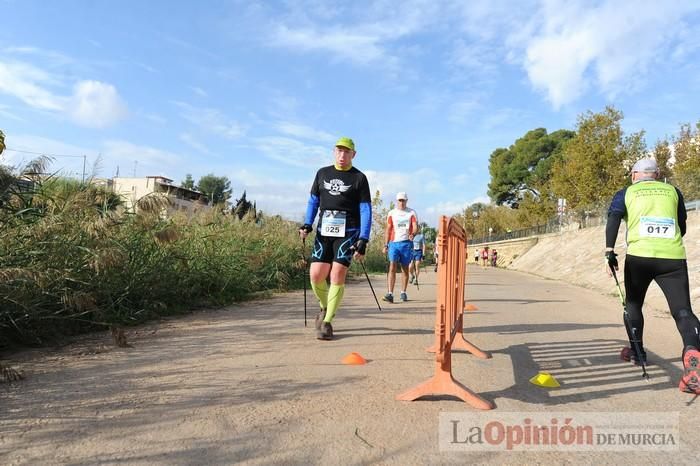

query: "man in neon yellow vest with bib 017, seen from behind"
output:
605 159 700 395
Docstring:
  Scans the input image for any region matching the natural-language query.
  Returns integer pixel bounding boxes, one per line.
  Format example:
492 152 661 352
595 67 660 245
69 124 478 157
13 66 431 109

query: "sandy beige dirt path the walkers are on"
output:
0 268 700 465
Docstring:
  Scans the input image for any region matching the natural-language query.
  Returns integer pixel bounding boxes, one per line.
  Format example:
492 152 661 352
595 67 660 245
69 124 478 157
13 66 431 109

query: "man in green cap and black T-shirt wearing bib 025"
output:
299 137 372 340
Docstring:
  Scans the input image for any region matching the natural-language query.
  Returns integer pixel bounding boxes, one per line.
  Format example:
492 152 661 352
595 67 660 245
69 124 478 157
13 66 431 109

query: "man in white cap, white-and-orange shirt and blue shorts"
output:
382 191 418 303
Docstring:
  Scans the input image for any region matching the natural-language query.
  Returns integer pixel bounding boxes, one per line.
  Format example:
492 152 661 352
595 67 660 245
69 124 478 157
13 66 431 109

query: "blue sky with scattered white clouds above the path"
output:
0 0 700 225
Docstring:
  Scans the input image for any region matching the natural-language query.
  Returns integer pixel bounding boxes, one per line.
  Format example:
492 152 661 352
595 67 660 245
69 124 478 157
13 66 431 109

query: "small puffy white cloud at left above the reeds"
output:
68 81 126 128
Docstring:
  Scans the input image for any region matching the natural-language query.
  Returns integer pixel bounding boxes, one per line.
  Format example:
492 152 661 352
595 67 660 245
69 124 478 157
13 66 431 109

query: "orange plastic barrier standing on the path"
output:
396 215 494 409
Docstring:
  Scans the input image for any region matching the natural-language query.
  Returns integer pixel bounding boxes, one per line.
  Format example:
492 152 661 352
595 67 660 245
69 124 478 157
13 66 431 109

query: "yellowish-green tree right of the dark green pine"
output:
551 106 646 213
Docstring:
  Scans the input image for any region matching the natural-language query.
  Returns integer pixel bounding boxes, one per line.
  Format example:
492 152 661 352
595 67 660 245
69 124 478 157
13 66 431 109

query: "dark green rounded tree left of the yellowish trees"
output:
488 128 574 207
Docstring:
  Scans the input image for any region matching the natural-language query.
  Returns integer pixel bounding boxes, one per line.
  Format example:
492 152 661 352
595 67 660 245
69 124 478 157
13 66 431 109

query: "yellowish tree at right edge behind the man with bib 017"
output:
673 122 700 200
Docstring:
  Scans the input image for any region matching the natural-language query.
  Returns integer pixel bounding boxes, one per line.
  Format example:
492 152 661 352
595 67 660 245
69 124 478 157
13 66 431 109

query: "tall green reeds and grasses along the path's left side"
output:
0 159 304 348
